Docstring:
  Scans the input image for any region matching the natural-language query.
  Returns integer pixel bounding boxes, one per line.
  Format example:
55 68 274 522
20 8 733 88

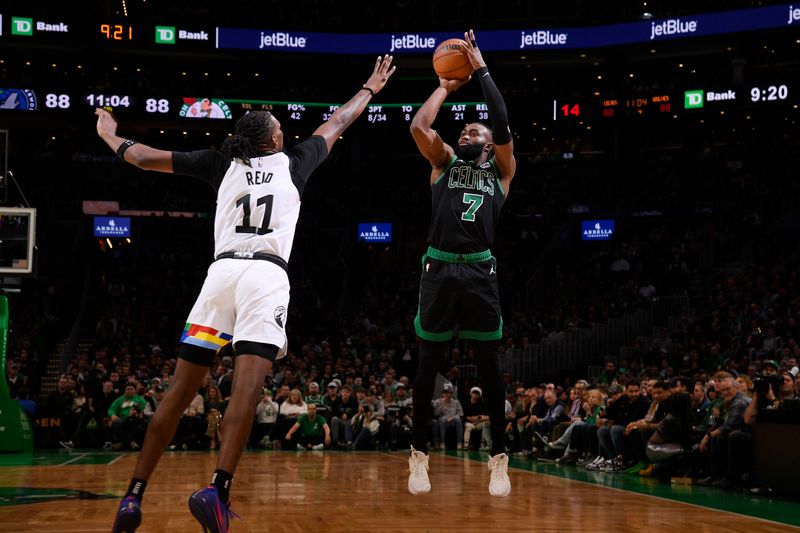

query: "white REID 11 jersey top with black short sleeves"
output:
173 136 327 262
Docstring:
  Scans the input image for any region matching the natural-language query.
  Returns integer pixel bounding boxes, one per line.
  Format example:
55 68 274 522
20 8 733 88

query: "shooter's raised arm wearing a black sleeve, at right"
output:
462 30 517 190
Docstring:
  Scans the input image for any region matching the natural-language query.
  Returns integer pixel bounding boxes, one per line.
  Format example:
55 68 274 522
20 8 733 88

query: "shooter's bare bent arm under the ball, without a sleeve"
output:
411 77 470 176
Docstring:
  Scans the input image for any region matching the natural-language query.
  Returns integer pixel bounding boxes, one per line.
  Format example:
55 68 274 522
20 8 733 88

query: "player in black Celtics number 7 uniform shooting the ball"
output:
408 30 516 496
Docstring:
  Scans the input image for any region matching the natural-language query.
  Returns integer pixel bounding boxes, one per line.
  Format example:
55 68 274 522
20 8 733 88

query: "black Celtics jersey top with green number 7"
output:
428 155 505 254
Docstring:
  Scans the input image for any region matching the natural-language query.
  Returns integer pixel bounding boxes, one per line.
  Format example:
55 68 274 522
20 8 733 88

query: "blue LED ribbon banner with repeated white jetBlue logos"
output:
216 4 800 54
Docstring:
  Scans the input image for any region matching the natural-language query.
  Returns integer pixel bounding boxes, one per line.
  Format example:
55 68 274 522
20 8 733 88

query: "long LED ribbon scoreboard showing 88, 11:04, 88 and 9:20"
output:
0 81 800 135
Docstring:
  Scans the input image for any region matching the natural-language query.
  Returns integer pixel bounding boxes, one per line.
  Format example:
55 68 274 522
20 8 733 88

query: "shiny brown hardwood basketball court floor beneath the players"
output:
0 452 800 533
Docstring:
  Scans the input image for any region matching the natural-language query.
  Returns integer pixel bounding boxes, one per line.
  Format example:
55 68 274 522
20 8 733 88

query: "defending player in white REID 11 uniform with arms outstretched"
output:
101 55 395 533
